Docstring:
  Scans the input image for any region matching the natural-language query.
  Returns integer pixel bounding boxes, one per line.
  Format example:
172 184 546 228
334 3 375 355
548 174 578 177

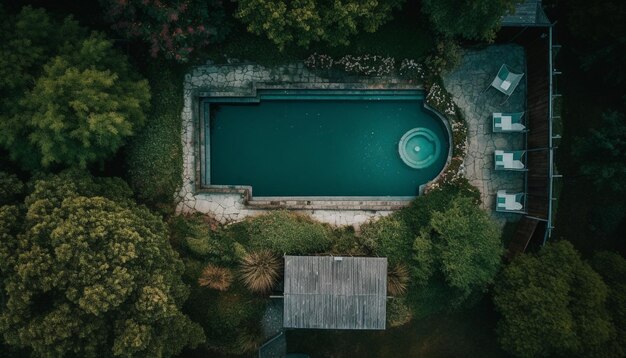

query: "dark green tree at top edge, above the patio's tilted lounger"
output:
422 0 522 41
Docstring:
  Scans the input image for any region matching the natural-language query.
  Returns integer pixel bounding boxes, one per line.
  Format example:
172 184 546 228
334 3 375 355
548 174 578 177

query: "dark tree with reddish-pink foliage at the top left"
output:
100 0 229 62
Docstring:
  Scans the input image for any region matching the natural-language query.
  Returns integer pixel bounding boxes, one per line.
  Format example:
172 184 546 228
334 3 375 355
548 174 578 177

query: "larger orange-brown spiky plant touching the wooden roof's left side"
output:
241 250 281 293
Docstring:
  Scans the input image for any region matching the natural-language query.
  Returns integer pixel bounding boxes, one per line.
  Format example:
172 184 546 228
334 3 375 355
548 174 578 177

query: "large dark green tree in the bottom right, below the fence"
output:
494 241 615 357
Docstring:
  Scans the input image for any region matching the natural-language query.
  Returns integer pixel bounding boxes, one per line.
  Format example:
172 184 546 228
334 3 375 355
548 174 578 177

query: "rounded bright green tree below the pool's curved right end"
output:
414 198 504 306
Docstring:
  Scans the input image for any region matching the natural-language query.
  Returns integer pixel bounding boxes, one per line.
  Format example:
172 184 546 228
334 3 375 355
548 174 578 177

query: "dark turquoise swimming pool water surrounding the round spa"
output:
203 90 449 197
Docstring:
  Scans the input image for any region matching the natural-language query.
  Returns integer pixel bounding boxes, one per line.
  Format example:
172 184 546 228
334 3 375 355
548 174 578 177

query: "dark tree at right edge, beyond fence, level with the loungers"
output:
573 111 626 193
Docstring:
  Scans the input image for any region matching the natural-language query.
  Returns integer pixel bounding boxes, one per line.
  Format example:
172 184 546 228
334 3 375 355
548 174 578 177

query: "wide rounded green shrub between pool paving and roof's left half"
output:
248 211 331 255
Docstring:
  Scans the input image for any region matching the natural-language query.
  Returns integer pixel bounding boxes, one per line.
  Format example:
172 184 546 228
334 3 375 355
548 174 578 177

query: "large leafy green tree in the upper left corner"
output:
0 7 150 169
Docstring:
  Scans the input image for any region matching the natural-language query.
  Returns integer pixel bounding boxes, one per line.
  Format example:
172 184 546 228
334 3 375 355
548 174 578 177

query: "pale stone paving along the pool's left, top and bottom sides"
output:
177 63 416 227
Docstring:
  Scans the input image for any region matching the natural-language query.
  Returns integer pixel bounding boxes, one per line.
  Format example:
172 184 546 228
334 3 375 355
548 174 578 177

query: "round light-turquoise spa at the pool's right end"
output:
398 127 441 169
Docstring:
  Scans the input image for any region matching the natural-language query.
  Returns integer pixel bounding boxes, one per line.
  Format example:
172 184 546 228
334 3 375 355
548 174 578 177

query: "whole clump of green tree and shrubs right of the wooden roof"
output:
352 185 504 318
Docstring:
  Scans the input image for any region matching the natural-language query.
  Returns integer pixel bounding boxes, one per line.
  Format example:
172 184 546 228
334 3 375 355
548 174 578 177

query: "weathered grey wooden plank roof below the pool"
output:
283 256 387 329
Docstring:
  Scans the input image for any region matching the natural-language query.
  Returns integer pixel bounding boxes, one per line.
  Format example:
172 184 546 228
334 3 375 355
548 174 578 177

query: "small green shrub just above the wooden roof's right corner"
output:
361 215 415 265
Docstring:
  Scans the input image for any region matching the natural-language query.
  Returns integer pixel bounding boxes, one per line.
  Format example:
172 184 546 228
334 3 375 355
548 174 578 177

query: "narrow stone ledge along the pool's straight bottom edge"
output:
247 199 410 211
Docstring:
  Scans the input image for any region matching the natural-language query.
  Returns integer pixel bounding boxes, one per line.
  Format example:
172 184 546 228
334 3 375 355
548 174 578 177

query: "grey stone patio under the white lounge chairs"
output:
443 45 526 219
